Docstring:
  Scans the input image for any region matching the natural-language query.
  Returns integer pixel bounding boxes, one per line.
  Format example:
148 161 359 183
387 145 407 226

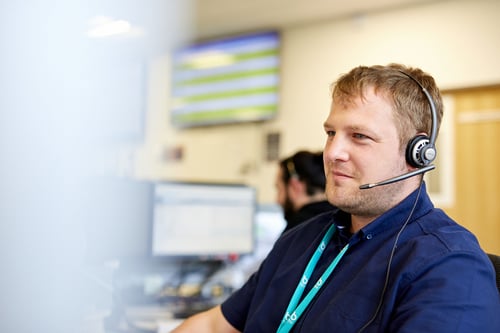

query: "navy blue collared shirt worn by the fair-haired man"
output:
222 184 500 333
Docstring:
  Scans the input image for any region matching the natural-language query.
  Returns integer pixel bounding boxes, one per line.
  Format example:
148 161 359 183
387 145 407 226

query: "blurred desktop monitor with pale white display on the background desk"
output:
151 182 256 258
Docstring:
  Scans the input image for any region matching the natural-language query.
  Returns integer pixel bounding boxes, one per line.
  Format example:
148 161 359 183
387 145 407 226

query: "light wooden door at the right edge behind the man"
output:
445 86 500 254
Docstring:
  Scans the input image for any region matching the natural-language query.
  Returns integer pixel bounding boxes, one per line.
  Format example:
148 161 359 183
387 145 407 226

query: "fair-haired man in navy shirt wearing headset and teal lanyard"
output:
174 64 500 333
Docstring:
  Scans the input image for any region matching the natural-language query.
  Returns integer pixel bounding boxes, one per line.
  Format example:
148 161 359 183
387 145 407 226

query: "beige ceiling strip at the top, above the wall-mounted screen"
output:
195 0 443 39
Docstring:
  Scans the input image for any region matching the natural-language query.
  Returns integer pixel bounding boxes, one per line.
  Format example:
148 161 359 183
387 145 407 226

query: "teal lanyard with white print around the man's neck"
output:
276 224 349 333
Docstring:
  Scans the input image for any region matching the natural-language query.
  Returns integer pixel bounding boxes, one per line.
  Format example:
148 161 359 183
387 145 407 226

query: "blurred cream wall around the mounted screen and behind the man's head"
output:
136 0 500 202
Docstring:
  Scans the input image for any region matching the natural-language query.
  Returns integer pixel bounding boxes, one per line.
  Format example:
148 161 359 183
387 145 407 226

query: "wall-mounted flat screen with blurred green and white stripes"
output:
171 32 280 127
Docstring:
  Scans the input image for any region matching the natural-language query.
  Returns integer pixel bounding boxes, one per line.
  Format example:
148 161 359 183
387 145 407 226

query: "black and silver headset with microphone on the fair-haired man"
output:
359 70 439 190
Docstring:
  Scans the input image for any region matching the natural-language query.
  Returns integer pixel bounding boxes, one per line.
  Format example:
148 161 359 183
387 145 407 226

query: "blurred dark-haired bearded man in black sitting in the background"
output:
276 150 335 233
